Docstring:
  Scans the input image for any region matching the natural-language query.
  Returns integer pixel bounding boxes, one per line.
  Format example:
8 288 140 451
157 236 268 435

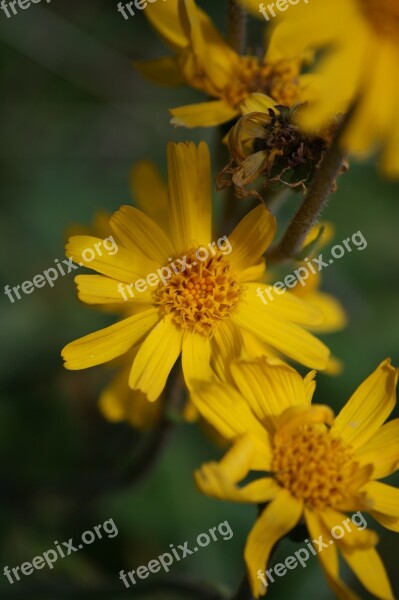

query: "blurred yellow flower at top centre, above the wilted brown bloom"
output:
135 0 307 127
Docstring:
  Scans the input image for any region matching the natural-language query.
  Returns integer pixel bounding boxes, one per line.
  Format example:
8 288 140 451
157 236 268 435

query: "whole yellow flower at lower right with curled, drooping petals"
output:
193 359 399 600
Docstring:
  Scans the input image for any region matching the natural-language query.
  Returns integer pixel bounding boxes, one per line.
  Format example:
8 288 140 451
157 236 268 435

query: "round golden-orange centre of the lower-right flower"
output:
272 425 354 509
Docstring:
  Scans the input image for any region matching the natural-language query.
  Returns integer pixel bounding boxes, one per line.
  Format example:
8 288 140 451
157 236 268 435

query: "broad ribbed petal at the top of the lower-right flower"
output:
231 359 307 434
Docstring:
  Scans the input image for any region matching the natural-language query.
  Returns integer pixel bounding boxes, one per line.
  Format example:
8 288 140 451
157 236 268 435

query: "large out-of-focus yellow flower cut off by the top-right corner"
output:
242 0 399 177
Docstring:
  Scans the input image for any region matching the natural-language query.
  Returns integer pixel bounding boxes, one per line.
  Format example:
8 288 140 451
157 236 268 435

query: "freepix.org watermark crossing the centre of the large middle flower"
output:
118 235 233 302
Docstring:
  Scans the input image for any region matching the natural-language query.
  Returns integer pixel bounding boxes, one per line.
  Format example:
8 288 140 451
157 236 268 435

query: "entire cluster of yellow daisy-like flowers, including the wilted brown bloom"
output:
62 0 399 600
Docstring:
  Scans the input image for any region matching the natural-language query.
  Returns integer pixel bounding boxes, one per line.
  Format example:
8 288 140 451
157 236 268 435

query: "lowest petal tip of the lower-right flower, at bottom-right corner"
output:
341 548 394 600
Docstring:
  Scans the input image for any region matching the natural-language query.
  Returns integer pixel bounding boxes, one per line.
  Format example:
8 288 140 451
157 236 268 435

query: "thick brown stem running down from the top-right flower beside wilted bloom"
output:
266 108 353 263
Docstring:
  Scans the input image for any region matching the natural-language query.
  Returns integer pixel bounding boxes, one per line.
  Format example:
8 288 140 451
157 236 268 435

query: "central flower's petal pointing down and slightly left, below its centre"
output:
129 316 183 402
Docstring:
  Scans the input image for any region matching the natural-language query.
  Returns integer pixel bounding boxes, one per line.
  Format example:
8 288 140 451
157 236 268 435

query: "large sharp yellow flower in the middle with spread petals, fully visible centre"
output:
62 143 329 401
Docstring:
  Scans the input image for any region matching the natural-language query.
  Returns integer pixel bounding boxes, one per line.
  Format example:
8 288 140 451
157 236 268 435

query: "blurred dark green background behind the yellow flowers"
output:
0 0 399 600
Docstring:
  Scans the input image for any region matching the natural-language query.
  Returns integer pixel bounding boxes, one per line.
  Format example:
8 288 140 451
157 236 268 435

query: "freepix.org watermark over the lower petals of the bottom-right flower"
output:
257 511 367 587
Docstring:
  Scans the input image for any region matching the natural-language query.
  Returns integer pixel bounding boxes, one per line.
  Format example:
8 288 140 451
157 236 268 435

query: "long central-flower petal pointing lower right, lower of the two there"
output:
232 303 330 369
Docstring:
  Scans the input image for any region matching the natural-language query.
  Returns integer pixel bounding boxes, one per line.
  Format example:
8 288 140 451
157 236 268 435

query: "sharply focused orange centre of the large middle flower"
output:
154 250 242 336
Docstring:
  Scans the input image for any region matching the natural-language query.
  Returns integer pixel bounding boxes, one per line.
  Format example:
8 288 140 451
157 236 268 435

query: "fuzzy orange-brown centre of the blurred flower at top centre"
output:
225 56 300 107
